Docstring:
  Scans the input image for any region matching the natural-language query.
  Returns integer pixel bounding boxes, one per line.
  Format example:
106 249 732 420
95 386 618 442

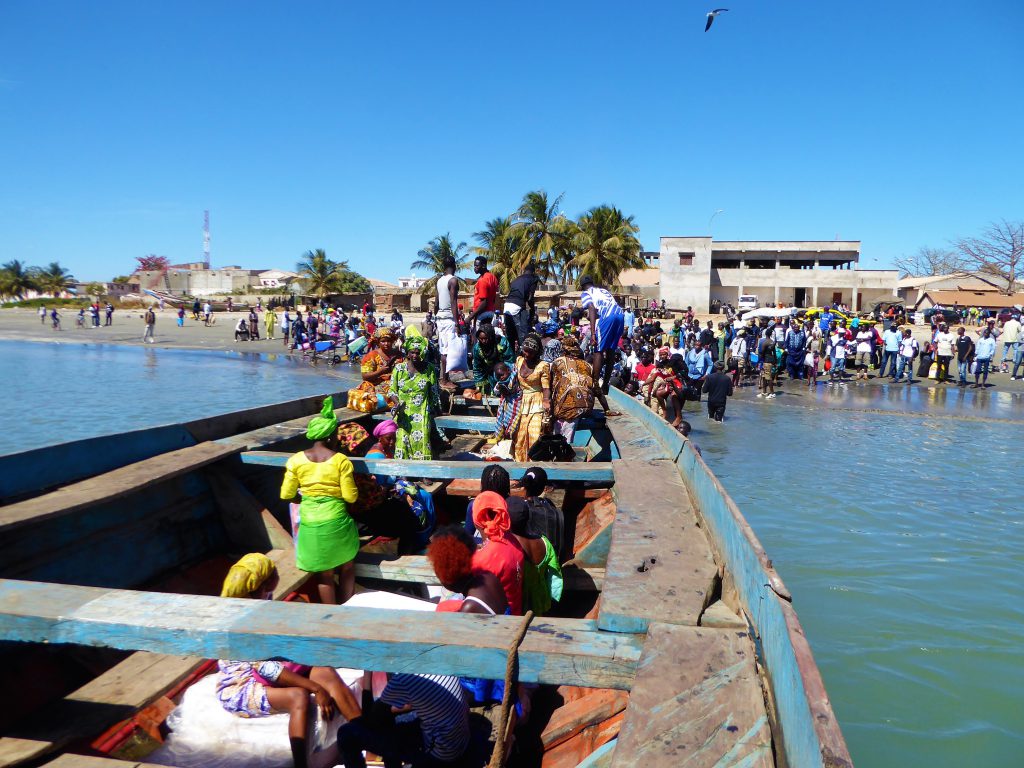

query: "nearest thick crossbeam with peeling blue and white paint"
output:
0 580 642 689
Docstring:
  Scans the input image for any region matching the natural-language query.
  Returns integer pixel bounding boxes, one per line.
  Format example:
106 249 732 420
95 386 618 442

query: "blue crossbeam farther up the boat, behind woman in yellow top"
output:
242 451 614 483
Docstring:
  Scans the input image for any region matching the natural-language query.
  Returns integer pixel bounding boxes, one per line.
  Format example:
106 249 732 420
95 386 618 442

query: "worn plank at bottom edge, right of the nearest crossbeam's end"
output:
611 624 774 768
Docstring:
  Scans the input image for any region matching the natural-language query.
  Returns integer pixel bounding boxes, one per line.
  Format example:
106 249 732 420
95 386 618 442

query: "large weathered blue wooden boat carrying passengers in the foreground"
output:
0 391 851 768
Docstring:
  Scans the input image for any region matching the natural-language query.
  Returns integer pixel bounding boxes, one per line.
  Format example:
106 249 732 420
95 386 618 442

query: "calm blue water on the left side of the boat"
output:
0 341 360 455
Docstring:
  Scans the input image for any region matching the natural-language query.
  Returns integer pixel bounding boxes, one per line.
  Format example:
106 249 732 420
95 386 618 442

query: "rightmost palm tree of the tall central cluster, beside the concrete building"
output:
572 206 646 286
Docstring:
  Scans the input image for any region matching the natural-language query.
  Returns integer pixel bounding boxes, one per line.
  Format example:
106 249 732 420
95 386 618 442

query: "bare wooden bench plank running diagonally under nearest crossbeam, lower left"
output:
0 550 309 768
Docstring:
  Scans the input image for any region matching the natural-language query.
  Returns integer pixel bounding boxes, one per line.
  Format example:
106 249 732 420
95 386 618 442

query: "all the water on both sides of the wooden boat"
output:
0 342 1024 767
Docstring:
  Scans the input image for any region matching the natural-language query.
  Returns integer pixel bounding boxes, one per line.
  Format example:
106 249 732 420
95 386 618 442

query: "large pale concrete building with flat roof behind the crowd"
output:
645 237 899 312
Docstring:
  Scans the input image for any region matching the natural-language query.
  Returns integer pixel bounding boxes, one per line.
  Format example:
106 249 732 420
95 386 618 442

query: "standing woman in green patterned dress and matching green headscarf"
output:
389 333 441 460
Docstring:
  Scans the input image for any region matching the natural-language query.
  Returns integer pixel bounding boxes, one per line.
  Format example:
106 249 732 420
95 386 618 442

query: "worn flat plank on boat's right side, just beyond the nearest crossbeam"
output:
597 461 718 632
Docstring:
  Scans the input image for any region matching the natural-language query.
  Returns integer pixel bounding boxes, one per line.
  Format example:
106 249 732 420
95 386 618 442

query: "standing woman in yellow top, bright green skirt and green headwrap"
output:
281 397 359 603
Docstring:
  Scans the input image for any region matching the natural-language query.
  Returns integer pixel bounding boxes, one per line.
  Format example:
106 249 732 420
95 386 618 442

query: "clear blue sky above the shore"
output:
0 0 1024 280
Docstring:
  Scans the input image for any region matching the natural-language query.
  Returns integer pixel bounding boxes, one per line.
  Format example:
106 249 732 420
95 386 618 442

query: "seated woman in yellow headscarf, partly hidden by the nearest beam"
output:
216 553 361 768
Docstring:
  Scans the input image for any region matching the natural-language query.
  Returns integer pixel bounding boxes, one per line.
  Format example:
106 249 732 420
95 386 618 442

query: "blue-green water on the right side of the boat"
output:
691 397 1024 766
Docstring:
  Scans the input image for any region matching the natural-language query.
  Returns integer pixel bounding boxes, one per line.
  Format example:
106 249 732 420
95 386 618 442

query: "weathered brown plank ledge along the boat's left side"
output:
0 442 241 528
